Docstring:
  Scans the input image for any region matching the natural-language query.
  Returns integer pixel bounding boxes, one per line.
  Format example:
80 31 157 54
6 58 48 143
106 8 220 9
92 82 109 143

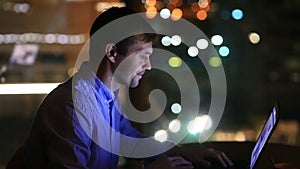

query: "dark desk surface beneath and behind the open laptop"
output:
184 142 300 169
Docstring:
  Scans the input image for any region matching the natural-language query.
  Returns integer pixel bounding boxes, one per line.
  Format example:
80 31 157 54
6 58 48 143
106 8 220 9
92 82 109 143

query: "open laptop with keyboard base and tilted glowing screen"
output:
209 102 279 169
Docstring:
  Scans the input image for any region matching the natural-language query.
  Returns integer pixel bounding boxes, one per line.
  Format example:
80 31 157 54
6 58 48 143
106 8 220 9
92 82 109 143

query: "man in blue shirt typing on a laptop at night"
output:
7 7 231 169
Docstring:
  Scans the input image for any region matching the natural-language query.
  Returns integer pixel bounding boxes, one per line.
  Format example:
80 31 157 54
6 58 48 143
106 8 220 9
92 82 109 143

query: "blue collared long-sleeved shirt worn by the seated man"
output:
24 63 143 169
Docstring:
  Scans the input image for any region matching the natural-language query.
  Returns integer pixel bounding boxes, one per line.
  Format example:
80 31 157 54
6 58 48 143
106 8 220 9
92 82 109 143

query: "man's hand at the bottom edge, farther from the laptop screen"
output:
145 156 194 169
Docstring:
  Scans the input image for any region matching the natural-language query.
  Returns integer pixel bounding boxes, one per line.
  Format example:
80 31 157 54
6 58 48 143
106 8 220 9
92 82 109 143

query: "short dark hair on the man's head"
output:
90 7 156 62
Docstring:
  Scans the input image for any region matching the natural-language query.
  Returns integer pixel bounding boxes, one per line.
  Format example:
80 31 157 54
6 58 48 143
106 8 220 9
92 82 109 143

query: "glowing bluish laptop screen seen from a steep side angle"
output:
249 104 278 169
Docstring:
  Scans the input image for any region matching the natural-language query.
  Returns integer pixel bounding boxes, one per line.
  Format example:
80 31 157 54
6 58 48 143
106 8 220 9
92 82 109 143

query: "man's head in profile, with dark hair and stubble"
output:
90 7 156 87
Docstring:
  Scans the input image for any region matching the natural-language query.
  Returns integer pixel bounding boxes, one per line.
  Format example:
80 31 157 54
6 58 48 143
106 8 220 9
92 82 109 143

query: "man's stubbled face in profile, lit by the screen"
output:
114 40 153 88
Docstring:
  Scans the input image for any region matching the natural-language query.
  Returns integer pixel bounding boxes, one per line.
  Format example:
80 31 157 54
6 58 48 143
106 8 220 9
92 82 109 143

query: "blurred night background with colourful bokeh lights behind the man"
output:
0 0 300 168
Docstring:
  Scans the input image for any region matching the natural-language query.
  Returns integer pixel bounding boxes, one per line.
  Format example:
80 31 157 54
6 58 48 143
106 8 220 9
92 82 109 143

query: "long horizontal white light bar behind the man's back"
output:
0 83 59 95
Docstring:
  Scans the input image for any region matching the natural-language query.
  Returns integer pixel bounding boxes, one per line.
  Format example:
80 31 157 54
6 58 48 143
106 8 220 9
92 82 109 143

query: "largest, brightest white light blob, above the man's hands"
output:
188 115 212 134
